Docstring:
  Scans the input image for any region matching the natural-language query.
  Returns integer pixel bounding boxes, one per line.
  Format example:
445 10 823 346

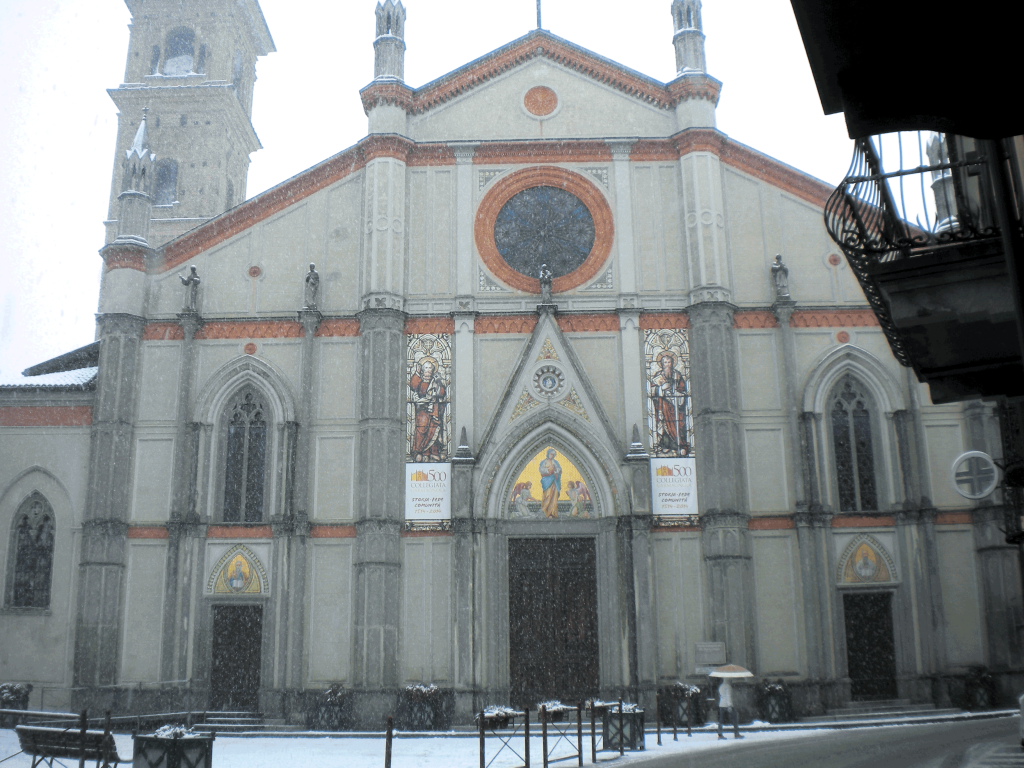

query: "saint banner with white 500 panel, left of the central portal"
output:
406 333 452 522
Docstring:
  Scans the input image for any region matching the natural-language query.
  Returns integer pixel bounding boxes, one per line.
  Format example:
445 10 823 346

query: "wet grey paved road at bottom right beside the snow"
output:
643 717 1024 768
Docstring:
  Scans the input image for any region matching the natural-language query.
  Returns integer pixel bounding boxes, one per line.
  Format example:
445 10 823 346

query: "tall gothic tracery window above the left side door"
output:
223 390 268 522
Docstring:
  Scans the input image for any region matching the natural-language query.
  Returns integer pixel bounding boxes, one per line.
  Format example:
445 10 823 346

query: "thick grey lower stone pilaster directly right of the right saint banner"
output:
689 302 756 671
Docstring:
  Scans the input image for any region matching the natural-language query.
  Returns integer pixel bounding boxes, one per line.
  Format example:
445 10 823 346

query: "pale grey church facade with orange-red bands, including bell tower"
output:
0 0 1024 727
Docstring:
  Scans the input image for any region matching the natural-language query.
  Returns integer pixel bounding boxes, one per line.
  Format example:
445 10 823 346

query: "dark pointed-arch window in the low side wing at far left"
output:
5 490 53 608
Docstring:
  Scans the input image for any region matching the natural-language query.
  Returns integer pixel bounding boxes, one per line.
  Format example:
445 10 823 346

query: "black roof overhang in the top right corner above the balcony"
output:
790 0 1024 138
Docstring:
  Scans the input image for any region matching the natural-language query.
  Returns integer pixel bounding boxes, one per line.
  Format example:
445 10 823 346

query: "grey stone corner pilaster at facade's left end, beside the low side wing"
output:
74 314 145 692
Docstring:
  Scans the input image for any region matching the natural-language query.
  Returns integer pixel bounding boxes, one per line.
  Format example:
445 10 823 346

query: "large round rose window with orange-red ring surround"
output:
474 166 614 294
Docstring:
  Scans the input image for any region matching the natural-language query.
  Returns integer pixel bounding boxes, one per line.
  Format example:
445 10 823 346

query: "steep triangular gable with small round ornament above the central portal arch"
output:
479 312 621 453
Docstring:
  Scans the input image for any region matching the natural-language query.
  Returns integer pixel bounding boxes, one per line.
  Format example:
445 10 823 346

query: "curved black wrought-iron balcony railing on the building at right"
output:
824 132 1000 367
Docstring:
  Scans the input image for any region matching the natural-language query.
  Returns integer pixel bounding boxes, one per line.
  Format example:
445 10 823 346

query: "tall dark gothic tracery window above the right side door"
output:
828 376 879 512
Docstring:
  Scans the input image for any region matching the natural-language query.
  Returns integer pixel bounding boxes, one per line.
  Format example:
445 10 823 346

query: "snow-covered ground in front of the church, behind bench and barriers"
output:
0 729 820 768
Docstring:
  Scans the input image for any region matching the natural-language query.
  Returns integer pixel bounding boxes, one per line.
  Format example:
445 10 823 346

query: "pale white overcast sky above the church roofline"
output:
0 0 852 377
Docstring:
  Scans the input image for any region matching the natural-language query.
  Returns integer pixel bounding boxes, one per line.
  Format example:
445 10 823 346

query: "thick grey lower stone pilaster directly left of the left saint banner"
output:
352 308 407 725
